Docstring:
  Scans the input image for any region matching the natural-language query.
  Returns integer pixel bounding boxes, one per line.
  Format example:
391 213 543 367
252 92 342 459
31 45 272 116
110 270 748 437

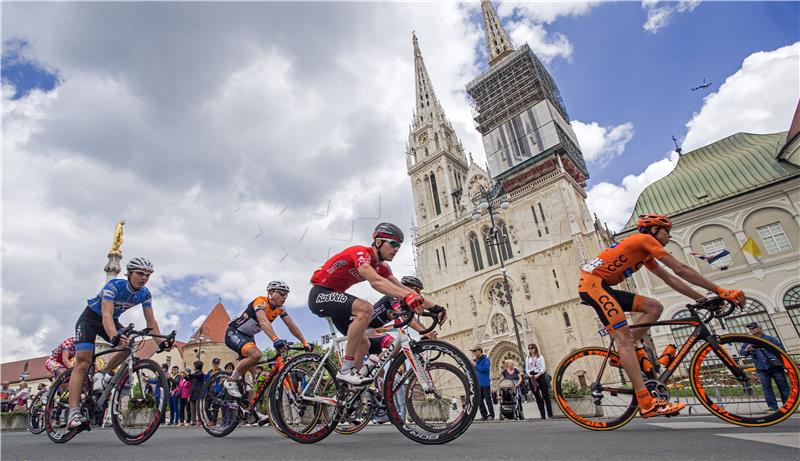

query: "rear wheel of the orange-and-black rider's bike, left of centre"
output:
199 371 240 437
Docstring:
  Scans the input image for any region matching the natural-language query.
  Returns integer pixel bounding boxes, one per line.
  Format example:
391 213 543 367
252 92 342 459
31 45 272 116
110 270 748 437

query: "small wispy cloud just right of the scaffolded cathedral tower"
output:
571 120 634 168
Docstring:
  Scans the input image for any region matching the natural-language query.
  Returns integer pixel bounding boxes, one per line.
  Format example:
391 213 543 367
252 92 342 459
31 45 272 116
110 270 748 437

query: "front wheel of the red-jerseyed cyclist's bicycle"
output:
383 340 480 444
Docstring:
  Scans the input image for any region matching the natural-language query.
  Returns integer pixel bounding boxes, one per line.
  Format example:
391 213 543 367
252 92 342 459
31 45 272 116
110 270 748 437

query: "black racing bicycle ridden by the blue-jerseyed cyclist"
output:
44 324 175 445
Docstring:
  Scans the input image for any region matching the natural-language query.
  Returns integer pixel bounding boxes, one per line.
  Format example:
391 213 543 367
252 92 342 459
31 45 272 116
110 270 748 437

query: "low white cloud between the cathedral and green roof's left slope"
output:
586 152 678 231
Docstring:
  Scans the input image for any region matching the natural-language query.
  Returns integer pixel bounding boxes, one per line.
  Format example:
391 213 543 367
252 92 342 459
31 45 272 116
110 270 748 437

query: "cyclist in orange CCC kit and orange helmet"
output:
578 214 745 418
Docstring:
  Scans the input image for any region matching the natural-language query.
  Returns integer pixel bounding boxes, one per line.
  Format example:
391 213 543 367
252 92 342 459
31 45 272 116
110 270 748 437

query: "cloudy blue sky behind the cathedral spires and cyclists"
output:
0 1 800 361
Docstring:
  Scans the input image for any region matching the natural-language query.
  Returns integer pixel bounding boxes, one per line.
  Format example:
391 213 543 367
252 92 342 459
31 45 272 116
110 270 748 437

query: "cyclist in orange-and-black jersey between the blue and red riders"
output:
224 280 314 399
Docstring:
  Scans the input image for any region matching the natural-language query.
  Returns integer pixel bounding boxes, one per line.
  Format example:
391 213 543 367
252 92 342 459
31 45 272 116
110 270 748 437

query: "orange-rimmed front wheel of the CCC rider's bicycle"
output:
689 334 800 427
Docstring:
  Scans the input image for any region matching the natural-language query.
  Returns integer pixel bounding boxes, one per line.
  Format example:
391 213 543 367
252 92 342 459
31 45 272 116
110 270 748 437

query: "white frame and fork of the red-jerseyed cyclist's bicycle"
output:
300 318 433 406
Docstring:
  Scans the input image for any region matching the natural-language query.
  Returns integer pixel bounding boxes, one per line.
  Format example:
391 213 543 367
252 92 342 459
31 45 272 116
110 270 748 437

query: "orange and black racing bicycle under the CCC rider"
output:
553 297 800 431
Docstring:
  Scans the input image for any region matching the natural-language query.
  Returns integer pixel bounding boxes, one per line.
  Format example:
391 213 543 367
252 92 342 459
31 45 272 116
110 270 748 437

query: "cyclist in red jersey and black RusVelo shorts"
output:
308 223 446 385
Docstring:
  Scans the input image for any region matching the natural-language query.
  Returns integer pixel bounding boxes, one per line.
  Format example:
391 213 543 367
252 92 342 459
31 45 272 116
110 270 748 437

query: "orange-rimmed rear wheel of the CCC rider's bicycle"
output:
553 347 638 431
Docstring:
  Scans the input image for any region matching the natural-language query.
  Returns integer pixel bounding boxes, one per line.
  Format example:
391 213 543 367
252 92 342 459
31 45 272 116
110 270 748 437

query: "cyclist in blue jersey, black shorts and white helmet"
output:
67 258 169 429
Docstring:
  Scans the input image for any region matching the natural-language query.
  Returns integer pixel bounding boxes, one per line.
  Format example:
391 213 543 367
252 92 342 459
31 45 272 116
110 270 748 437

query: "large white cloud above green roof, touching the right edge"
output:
683 42 800 152
